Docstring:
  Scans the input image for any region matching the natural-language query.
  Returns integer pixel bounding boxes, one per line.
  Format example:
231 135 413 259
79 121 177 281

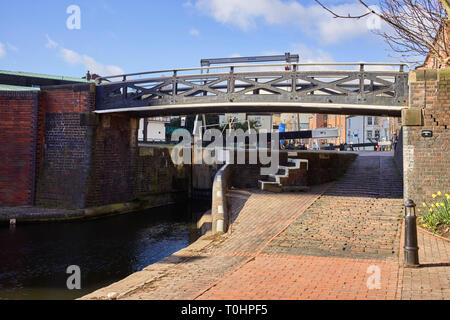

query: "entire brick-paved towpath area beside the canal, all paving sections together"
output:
81 154 450 300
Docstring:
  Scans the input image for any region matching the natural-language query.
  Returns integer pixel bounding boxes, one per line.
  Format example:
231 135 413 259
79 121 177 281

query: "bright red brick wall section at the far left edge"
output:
0 91 38 206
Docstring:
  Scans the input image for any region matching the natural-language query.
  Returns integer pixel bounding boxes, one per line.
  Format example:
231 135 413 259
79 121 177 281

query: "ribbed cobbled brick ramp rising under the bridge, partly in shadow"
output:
264 157 403 260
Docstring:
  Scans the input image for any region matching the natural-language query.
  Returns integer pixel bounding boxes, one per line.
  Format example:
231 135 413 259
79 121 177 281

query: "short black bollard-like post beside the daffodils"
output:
404 199 420 268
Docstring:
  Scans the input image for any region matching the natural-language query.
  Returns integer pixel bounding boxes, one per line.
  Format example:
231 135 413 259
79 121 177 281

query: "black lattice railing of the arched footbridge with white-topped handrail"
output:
96 62 409 110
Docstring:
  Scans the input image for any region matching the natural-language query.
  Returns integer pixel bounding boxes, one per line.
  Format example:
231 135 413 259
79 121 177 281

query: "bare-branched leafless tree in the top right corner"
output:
315 0 450 65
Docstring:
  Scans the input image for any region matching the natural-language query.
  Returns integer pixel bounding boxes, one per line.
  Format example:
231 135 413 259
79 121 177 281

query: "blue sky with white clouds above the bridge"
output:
0 0 410 78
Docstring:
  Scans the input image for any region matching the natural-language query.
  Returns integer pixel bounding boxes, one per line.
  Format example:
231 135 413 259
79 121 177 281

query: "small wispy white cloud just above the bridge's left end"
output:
45 35 125 76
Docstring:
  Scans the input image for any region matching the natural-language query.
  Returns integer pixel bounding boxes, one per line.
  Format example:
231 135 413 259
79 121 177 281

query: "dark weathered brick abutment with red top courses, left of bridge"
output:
35 84 95 208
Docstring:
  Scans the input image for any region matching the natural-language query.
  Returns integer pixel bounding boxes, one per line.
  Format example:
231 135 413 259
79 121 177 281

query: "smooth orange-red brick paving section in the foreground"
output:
200 255 398 300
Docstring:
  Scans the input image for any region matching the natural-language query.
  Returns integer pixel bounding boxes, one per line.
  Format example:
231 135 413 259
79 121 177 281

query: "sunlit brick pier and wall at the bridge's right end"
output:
403 69 450 203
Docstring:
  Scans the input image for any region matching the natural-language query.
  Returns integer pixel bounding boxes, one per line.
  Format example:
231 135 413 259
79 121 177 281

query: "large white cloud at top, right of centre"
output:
194 0 384 43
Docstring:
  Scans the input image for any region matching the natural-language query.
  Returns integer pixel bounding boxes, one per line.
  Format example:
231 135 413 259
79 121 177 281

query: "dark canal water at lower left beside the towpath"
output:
0 201 210 300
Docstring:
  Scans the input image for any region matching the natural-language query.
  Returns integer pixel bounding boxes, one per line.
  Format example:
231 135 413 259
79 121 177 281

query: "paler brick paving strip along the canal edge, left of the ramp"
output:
83 185 328 300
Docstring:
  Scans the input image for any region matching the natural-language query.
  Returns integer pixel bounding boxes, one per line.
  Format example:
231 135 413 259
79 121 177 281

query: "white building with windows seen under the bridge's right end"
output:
346 116 391 150
